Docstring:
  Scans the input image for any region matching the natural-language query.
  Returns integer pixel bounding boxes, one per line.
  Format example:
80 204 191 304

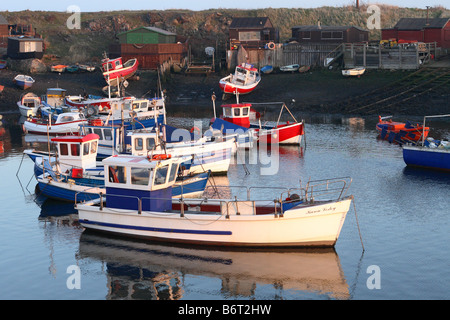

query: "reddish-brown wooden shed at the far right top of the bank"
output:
381 18 450 49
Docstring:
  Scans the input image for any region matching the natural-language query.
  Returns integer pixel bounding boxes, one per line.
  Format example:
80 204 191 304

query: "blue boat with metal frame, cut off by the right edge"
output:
402 115 450 171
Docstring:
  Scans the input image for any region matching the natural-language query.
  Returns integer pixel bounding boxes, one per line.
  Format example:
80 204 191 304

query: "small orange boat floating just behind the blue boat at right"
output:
376 116 430 143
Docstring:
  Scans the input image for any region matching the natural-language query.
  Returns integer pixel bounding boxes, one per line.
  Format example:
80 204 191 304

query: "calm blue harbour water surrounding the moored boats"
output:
0 112 450 300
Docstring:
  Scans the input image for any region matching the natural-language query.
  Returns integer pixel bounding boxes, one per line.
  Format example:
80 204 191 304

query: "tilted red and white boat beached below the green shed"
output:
102 57 139 86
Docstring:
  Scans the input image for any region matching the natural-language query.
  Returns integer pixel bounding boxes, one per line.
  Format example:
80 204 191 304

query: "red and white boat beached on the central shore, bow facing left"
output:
219 63 261 94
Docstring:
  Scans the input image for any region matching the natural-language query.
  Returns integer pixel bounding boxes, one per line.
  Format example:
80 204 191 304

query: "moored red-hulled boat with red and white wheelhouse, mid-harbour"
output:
211 103 305 145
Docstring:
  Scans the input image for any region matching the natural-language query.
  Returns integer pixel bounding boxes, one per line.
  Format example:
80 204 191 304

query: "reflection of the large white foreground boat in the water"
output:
77 230 350 300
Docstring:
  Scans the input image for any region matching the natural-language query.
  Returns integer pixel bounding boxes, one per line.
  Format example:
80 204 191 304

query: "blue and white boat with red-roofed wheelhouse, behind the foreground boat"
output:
24 134 210 201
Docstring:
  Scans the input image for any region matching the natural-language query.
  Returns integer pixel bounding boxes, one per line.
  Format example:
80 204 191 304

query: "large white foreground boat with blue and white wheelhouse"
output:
75 155 353 248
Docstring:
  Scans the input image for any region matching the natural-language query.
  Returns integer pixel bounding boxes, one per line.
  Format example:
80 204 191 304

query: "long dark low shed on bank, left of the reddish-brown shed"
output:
290 23 369 44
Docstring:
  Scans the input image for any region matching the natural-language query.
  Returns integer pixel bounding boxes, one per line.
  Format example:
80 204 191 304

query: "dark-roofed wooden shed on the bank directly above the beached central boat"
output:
229 17 279 50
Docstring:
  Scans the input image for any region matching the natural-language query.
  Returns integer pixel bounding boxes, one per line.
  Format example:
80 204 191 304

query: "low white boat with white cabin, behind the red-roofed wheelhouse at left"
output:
23 112 87 135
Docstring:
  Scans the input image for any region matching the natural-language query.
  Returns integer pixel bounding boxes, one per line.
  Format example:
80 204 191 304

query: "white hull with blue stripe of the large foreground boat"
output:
76 198 351 247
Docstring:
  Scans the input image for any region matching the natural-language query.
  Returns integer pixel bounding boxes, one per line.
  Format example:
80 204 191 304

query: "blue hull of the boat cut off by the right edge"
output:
403 146 450 171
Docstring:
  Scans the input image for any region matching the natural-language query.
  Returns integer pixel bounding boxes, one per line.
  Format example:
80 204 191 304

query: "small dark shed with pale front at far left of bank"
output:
7 36 44 59
